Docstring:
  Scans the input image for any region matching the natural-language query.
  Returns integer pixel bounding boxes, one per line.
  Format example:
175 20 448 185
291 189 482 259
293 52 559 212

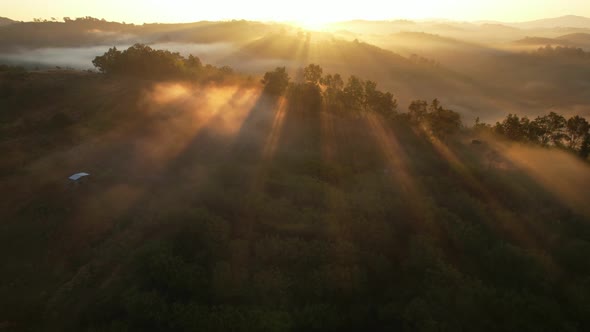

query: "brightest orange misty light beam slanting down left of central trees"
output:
56 84 260 249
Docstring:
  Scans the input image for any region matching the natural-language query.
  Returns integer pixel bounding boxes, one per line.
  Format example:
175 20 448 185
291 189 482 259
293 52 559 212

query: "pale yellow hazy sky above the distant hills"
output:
0 0 590 24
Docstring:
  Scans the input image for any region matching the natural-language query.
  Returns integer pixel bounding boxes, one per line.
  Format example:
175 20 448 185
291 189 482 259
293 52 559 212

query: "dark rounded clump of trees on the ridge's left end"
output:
92 44 234 79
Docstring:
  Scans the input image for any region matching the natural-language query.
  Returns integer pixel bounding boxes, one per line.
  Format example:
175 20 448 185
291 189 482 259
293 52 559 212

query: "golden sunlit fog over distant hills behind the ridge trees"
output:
0 21 590 123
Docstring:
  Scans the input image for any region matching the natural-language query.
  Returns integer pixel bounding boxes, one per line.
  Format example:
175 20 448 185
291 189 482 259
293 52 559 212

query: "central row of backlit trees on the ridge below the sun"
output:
261 64 463 138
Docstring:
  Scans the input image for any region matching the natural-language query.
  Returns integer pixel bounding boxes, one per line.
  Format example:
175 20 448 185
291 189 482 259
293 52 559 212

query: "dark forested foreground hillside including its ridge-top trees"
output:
0 45 590 331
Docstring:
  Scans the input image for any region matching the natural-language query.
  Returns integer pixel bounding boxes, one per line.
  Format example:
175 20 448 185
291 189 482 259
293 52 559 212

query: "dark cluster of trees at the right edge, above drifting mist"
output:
474 112 590 159
